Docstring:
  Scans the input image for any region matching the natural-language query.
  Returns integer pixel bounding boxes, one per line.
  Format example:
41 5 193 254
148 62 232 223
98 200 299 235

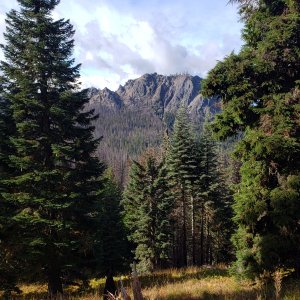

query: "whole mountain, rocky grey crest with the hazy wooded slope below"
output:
87 73 220 185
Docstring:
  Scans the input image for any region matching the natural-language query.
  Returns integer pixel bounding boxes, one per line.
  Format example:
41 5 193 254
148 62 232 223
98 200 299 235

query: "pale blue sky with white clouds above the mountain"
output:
0 0 243 90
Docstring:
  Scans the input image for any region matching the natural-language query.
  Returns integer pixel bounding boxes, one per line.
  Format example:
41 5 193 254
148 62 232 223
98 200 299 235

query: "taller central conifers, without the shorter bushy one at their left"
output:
165 107 232 267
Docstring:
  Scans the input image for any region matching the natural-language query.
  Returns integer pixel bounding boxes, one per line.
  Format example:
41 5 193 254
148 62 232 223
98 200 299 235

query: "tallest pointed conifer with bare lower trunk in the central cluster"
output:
167 107 197 267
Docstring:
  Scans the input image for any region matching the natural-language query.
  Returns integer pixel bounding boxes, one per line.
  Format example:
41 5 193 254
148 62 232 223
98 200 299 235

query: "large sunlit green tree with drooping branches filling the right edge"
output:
203 0 300 278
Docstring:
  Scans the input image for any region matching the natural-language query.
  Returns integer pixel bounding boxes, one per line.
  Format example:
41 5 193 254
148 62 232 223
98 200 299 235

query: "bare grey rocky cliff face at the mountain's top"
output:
89 73 219 121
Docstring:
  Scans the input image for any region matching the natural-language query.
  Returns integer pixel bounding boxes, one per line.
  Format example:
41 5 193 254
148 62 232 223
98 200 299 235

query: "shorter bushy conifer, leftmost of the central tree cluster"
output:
123 152 173 272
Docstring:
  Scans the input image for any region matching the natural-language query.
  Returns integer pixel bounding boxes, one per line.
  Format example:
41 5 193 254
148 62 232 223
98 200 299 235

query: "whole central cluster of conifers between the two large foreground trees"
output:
122 107 233 271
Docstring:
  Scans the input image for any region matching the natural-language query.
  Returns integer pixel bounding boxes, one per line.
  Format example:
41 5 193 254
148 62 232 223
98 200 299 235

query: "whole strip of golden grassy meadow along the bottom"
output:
4 267 300 300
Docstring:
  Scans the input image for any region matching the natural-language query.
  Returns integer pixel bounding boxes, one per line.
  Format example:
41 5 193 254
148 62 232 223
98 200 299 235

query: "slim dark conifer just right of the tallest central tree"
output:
197 123 233 264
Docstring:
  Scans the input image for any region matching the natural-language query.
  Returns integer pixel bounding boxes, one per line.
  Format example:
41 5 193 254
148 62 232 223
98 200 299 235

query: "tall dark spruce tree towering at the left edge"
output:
0 0 103 295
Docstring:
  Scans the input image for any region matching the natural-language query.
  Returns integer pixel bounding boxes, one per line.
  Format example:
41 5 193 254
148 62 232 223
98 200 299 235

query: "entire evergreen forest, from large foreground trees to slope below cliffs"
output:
0 0 300 299
